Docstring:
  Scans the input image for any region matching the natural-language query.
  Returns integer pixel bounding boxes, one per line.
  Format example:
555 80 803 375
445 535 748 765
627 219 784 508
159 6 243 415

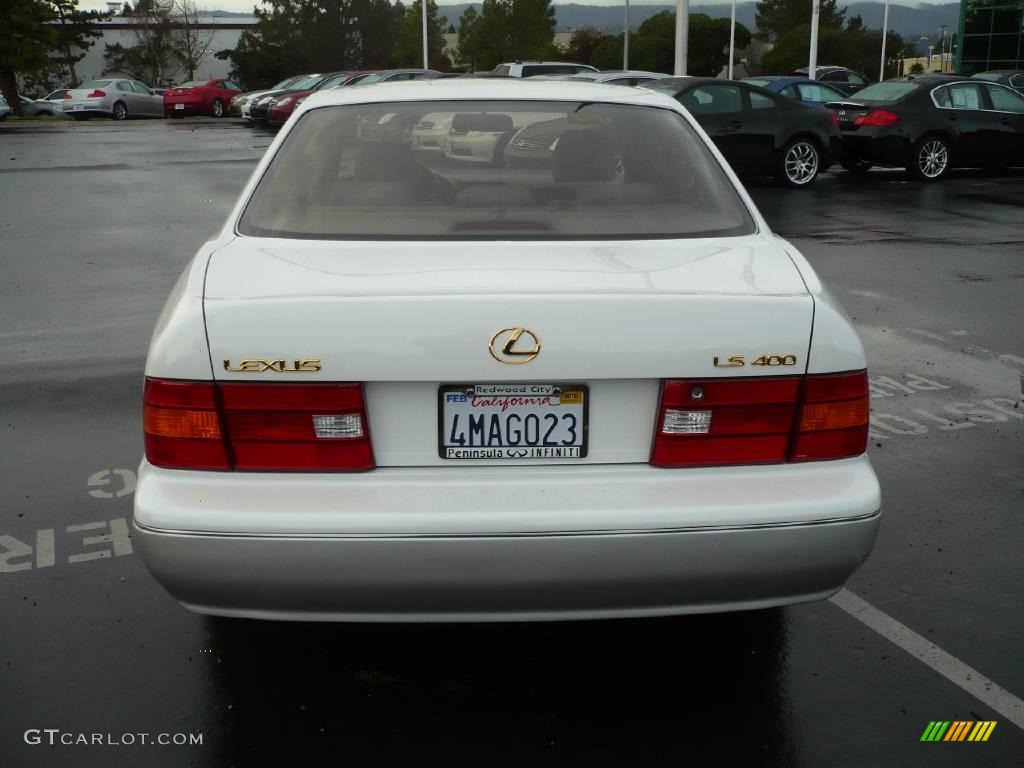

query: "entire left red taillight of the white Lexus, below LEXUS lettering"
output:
145 379 375 471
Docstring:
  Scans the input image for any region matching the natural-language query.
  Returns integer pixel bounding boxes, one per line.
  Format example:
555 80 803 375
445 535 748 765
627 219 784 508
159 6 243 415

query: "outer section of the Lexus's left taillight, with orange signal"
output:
142 379 230 469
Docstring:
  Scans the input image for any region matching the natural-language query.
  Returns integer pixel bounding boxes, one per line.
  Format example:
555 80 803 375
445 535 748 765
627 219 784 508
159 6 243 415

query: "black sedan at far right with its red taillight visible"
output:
828 75 1024 181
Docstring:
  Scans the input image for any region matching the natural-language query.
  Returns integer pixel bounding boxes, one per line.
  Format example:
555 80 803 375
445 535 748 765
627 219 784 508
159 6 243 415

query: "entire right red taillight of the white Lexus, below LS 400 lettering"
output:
650 371 868 467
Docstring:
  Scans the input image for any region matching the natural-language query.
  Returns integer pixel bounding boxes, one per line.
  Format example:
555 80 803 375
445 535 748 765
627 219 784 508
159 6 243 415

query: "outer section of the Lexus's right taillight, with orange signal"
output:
790 371 870 462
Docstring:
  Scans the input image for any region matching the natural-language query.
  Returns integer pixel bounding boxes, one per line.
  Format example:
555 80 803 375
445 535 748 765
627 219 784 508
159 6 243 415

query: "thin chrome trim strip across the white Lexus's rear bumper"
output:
132 509 882 540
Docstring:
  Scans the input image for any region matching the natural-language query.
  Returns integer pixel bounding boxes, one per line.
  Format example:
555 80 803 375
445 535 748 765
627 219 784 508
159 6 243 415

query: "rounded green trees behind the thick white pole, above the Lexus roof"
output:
591 10 751 77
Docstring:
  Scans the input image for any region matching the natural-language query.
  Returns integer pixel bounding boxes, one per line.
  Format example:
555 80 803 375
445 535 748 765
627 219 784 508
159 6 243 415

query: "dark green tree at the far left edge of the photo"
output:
0 0 56 115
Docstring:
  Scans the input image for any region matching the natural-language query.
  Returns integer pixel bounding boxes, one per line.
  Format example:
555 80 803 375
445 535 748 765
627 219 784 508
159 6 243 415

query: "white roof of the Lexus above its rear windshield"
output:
302 78 678 110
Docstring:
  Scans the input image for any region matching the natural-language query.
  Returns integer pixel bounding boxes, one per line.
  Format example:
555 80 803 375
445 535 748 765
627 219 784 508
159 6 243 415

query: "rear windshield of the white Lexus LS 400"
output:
239 100 755 240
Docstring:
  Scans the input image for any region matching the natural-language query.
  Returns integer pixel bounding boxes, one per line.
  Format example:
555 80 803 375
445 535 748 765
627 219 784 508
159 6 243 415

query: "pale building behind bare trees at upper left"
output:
75 3 256 87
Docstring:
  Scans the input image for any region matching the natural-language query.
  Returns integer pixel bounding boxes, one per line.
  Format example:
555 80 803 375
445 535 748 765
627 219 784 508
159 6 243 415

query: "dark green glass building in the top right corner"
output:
956 0 1024 75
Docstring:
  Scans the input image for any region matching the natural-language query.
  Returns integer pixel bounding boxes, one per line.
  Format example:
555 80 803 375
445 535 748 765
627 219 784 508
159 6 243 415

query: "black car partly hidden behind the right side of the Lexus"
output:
643 78 842 188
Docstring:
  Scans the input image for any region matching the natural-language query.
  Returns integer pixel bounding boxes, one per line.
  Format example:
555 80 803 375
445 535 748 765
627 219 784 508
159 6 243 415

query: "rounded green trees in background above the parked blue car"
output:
761 25 905 80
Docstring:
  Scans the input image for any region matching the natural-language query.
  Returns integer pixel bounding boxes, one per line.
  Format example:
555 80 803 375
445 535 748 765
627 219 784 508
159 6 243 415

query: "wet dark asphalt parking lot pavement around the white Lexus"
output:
0 121 1024 768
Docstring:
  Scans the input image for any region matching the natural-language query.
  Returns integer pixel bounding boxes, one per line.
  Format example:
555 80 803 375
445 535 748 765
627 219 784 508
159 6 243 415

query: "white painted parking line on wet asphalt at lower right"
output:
828 589 1024 729
